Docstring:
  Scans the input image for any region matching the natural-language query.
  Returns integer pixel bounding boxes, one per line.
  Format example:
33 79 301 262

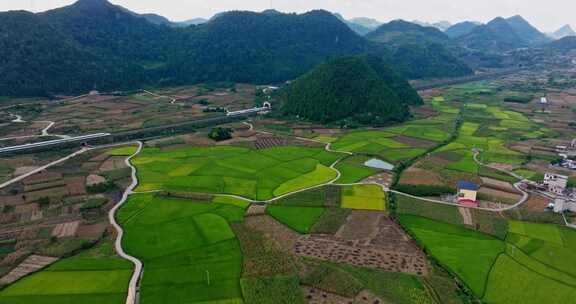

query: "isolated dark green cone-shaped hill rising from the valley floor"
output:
282 56 422 125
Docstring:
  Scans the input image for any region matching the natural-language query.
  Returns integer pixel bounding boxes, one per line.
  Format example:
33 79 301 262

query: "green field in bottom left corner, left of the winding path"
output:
0 243 133 304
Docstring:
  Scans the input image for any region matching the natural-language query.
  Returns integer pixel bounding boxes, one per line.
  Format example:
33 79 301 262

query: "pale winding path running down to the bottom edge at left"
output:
108 141 144 304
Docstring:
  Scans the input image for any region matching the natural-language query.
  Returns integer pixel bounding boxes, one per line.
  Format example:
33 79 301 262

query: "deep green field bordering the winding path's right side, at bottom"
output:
117 194 244 304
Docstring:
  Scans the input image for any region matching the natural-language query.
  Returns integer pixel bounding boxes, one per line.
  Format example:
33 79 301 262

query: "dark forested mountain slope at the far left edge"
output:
0 11 146 96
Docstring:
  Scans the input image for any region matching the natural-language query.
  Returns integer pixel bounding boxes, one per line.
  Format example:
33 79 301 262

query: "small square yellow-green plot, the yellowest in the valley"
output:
341 185 386 211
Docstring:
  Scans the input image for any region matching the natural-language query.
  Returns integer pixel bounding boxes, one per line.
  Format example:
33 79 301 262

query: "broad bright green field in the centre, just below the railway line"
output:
134 146 342 200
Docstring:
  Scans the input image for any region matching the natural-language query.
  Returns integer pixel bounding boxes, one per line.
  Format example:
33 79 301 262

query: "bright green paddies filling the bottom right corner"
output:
399 214 576 304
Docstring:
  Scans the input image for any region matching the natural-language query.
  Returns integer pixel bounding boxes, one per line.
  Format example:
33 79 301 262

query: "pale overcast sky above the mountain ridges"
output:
0 0 576 32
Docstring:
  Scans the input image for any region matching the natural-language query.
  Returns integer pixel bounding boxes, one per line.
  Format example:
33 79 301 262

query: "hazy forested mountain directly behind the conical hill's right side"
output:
366 20 473 79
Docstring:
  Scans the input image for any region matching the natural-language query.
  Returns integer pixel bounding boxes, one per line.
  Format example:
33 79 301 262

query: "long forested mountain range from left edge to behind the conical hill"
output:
0 0 368 96
